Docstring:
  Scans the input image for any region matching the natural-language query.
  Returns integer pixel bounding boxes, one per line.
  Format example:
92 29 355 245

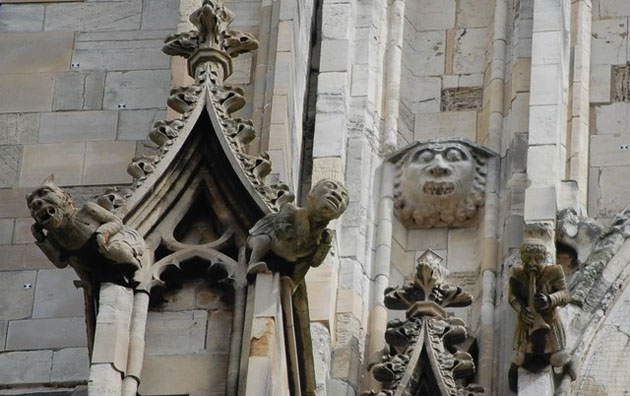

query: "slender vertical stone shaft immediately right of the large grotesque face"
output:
478 0 508 394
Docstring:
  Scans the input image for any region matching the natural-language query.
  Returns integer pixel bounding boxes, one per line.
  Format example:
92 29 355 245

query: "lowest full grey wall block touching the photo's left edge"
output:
0 351 53 385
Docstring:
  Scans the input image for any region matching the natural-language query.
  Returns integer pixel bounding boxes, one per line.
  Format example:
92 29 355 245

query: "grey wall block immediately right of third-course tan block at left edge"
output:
53 71 105 111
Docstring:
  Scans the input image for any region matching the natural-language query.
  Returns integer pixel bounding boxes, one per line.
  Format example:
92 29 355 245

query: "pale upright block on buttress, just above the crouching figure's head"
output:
313 113 346 158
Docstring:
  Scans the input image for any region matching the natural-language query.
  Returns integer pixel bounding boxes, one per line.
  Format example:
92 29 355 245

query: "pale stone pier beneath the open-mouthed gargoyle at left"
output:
88 283 133 396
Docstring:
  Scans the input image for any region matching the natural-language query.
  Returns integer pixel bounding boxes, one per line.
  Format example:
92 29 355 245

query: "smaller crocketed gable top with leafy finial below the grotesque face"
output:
366 249 483 396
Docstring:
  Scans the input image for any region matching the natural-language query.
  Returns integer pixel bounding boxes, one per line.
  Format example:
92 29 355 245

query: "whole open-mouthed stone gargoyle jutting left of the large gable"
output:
26 176 146 284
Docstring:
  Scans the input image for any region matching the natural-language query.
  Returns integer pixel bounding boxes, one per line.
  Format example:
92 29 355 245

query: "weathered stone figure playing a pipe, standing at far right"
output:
508 241 575 395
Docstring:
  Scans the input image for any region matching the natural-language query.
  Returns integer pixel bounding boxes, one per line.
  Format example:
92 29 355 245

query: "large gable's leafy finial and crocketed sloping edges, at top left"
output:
123 0 294 211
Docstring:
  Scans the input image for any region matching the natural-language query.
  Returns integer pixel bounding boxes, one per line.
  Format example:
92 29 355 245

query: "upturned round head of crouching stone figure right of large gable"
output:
307 179 348 221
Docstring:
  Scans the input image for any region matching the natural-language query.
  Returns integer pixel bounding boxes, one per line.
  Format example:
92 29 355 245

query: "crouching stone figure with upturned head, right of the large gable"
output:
248 179 348 281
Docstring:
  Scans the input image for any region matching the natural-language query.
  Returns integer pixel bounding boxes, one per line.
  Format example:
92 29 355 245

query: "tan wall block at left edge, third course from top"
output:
0 74 55 113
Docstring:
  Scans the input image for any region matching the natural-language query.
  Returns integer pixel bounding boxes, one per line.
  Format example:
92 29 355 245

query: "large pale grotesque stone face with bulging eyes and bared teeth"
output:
393 139 492 228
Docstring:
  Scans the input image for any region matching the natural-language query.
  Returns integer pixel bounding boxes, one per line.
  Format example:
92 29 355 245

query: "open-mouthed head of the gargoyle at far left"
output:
26 176 76 230
